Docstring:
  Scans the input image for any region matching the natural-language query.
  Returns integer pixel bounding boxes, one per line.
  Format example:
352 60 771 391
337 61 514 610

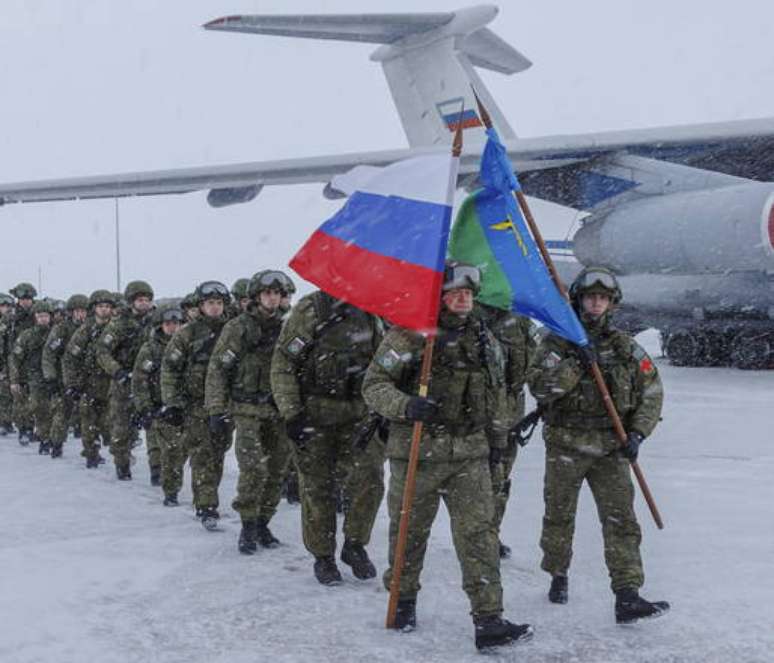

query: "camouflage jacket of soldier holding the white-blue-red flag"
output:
363 312 507 462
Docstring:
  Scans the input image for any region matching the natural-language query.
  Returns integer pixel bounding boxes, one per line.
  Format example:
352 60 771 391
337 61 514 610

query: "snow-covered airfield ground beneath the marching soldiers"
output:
0 335 774 663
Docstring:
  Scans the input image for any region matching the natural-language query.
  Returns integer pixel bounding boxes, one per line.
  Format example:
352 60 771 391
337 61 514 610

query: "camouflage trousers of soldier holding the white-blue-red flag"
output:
384 458 503 616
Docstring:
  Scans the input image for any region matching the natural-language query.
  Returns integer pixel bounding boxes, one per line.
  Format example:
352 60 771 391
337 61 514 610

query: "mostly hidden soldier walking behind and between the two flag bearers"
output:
474 303 535 559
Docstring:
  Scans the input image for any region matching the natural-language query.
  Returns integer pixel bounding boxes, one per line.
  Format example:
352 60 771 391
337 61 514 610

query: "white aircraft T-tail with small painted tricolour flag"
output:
204 5 532 147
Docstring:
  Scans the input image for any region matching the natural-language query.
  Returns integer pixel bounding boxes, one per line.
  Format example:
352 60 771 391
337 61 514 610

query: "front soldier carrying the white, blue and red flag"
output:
363 262 532 649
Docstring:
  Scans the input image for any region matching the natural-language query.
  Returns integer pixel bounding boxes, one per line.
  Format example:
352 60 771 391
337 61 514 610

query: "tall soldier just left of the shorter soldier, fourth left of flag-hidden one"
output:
97 281 153 481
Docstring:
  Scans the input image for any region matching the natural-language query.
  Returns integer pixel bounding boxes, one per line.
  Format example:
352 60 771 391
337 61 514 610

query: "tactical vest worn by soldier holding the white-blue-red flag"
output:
399 318 505 436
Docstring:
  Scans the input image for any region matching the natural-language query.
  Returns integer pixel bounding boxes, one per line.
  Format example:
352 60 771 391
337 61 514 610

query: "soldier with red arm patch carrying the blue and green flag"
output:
528 267 669 624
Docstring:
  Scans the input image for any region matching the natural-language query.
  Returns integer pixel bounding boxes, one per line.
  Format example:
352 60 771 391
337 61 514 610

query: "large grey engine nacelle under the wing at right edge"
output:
573 183 774 274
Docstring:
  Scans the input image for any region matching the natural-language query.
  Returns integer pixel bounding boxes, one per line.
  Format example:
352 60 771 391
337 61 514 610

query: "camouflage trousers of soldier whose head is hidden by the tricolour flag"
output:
294 425 384 557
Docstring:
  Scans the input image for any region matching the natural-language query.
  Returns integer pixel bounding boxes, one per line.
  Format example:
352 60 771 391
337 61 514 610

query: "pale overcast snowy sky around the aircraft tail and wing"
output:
0 0 774 297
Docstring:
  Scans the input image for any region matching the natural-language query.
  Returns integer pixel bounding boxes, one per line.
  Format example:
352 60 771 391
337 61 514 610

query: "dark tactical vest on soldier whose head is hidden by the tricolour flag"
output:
299 292 378 400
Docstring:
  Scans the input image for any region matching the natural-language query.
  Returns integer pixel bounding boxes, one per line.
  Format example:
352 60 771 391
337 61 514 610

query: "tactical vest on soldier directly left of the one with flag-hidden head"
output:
231 312 282 405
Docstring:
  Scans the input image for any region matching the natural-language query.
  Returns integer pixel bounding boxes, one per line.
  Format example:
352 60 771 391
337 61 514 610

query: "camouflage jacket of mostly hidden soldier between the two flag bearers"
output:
475 305 537 428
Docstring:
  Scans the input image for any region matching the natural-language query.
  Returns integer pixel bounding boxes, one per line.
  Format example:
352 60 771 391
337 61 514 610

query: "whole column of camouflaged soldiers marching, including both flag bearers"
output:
0 263 669 649
